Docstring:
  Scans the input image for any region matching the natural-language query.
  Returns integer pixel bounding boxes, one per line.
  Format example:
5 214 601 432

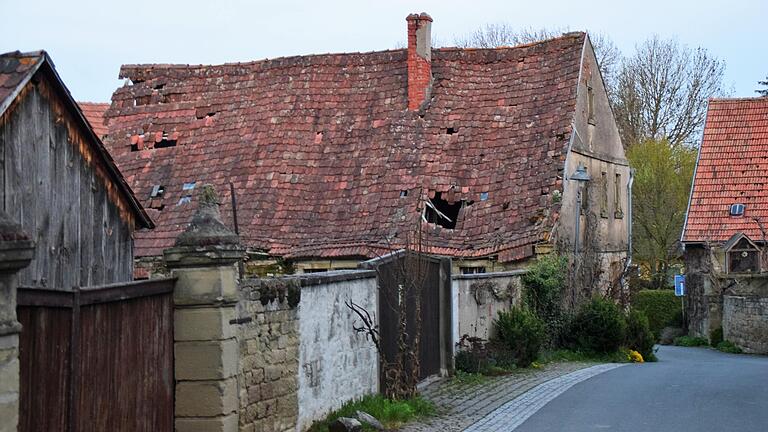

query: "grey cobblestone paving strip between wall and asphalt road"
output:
400 363 620 432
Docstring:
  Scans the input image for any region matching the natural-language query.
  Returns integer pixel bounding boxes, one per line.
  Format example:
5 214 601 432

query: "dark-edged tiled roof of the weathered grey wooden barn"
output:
0 51 154 228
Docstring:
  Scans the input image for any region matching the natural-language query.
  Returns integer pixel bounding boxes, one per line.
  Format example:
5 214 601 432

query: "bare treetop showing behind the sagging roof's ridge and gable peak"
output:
454 23 621 92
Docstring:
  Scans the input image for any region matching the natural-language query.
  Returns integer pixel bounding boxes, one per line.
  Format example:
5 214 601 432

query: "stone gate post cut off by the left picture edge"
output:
0 210 35 432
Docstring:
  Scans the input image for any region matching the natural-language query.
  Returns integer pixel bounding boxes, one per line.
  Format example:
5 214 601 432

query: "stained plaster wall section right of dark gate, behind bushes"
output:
451 270 525 344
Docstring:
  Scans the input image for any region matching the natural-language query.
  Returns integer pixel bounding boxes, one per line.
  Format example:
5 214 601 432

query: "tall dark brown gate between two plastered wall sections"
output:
361 251 453 390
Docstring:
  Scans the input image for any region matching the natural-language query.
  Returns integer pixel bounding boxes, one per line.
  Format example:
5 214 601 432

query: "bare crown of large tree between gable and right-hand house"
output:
610 36 725 147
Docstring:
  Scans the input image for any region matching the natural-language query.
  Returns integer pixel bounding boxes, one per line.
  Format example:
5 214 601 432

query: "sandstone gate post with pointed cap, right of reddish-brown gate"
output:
164 185 244 432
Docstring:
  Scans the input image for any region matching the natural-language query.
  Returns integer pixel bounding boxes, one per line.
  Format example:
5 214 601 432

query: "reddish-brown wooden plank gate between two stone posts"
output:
17 279 174 432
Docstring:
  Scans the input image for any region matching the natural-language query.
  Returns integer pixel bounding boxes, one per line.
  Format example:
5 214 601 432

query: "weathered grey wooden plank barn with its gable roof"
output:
0 51 153 290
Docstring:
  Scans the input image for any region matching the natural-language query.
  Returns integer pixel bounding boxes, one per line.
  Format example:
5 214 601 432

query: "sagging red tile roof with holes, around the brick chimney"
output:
99 33 585 261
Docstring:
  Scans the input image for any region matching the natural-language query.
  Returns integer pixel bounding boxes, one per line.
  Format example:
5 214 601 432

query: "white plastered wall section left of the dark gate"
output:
297 271 379 431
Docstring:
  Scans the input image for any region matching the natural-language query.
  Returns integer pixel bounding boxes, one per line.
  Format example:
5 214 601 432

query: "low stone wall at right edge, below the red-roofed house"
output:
723 296 768 354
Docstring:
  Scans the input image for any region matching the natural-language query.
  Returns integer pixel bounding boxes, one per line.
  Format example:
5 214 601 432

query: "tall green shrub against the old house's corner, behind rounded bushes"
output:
522 254 568 346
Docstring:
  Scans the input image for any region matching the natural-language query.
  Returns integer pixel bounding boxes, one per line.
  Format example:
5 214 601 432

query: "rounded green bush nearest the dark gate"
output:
493 307 546 367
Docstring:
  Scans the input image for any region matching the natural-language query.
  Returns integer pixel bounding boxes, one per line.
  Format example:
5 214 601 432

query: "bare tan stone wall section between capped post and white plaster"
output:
237 279 301 432
